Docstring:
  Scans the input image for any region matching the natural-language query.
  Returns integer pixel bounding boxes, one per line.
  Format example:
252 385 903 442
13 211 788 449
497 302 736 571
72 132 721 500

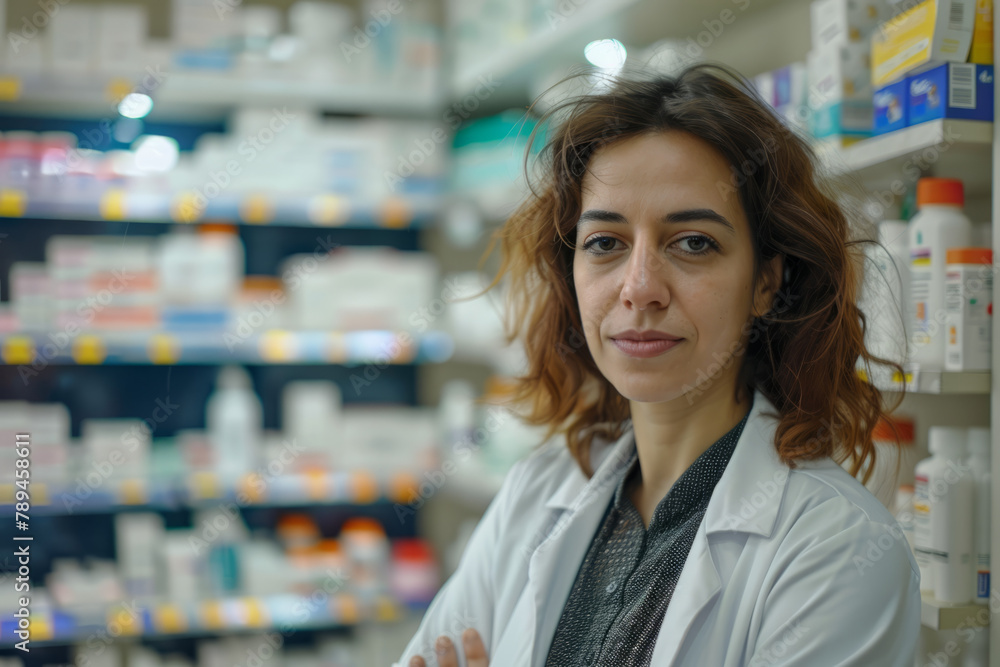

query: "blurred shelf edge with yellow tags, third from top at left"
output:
0 329 454 371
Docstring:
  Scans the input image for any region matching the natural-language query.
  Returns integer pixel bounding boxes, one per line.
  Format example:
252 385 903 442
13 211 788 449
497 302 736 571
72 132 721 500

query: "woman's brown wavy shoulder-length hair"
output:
474 63 903 483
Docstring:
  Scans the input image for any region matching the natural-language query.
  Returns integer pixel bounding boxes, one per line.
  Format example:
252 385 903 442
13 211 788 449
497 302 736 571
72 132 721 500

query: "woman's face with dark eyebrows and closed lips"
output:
573 131 781 402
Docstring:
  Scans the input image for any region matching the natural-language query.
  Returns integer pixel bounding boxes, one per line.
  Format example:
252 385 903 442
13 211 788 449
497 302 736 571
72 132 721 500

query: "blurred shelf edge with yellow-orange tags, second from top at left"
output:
0 188 440 229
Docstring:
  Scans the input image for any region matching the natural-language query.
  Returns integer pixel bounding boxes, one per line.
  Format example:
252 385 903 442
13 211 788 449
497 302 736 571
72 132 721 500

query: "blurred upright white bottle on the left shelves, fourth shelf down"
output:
205 366 264 484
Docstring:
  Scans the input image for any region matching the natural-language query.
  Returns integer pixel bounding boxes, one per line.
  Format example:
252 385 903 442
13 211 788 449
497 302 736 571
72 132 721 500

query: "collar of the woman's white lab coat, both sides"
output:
546 389 788 537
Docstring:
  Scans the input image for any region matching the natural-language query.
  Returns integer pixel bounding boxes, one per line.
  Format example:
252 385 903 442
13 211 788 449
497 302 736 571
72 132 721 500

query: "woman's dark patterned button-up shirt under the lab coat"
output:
545 400 750 667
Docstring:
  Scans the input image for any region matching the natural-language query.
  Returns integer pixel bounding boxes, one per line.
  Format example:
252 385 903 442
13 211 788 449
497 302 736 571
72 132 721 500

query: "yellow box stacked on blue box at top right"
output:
872 0 977 88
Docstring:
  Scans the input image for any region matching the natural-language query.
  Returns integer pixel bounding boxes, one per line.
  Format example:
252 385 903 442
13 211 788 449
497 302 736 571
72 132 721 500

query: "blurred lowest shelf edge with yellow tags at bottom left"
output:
0 596 424 649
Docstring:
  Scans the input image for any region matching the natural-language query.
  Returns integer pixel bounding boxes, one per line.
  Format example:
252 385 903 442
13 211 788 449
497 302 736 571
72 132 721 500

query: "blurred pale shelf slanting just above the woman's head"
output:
449 0 792 115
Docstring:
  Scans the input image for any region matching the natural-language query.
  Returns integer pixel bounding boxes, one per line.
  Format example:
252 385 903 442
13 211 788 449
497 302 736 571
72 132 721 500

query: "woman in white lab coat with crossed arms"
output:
397 65 920 667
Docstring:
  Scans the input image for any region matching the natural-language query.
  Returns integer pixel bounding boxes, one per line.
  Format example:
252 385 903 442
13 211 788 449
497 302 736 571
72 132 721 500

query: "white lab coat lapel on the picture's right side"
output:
651 390 788 667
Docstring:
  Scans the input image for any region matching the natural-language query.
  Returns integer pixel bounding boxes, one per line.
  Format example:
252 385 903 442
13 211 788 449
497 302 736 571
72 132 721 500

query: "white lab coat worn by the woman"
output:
393 391 920 667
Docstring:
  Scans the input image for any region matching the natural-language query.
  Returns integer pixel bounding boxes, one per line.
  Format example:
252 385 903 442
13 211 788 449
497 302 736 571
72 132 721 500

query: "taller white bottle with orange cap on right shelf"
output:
910 178 972 370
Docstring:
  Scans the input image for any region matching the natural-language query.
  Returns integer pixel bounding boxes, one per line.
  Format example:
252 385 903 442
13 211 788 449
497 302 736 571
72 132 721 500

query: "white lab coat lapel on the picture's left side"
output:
516 423 635 667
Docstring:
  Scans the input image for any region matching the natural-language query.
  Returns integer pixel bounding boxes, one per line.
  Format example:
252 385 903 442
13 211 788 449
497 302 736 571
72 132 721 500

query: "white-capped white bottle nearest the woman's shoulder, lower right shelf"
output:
926 426 975 604
